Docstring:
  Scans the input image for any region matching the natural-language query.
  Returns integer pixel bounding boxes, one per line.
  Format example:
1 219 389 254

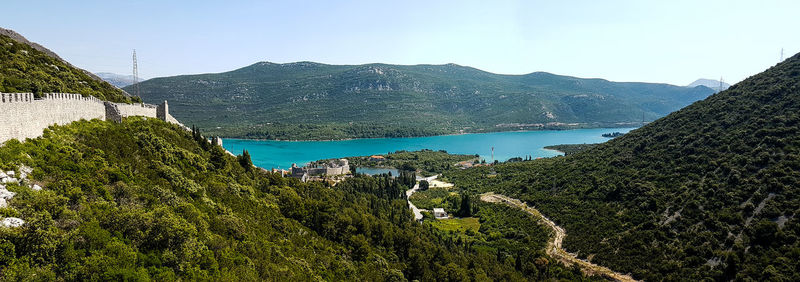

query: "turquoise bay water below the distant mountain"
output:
223 128 633 169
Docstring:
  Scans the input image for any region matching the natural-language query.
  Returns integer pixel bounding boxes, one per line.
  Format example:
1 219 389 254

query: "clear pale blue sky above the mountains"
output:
0 0 800 85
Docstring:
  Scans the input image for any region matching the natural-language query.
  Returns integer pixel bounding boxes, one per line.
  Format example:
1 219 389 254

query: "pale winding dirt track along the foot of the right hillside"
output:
481 192 636 281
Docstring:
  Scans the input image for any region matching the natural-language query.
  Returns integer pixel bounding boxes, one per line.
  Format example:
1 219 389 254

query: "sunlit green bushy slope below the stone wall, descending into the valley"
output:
0 118 592 281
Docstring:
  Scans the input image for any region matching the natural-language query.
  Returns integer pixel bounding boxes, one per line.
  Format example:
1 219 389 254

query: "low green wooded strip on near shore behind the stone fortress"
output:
346 150 478 176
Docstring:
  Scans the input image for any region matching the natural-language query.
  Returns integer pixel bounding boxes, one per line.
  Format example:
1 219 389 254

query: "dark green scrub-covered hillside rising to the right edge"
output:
446 55 800 281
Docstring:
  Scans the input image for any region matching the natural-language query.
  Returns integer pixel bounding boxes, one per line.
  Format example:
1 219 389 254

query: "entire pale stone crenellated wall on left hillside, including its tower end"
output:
0 93 186 143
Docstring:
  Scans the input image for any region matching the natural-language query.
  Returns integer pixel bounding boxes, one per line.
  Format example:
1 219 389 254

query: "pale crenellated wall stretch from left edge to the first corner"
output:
0 93 106 142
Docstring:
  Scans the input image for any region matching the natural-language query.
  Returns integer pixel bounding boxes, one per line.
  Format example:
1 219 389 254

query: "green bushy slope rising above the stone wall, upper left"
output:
0 35 139 103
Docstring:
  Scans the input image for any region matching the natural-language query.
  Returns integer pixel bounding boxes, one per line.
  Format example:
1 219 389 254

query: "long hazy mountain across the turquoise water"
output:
126 62 714 139
